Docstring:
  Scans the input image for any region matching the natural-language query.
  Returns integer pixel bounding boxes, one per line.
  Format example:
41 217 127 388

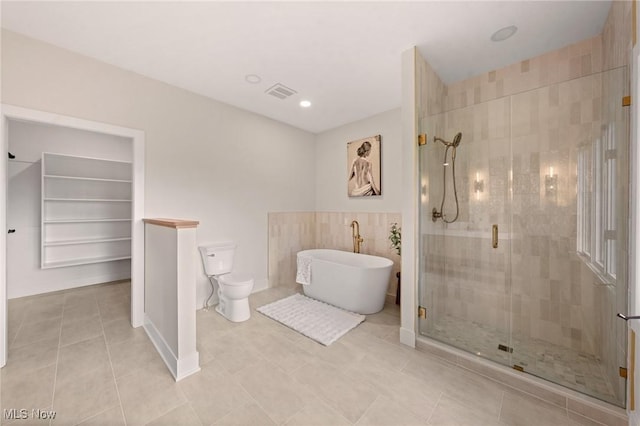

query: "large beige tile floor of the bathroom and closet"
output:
0 282 616 426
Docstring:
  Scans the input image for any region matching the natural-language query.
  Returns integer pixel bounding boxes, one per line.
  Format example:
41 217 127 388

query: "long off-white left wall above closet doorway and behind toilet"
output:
1 30 315 306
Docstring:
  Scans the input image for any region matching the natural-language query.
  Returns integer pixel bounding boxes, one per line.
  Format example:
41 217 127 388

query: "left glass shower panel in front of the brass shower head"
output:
419 98 512 365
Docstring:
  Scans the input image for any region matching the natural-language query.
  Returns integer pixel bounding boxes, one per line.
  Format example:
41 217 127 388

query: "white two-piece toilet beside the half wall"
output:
199 242 253 322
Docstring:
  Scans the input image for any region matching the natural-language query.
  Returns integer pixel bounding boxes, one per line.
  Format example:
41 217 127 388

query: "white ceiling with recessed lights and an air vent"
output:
1 0 611 133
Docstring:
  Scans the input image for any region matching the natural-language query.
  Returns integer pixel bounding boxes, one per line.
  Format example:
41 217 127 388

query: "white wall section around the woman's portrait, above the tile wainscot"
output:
315 109 402 213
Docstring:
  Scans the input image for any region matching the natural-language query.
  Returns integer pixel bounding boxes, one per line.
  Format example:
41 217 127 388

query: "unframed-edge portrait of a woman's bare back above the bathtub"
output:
347 135 382 197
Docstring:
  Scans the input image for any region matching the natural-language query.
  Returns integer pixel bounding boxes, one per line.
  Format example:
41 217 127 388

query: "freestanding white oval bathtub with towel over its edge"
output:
298 249 393 314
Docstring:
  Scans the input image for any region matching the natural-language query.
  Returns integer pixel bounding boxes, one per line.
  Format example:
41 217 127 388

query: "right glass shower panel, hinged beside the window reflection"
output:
511 67 629 406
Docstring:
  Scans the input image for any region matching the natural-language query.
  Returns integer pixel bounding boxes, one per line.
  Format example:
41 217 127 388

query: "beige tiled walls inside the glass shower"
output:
417 2 631 406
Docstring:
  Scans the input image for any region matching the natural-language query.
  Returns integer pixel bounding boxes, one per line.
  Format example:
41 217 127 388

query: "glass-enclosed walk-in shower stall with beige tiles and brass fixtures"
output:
416 50 629 407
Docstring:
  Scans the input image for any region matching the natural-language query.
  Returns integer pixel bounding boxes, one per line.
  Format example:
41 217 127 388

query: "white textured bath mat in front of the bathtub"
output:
257 293 366 346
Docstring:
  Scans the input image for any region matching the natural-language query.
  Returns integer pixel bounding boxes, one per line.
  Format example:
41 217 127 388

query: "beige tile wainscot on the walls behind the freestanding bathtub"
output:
268 212 402 295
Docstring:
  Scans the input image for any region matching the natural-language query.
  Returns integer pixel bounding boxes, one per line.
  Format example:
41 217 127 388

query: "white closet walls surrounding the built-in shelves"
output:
7 121 132 299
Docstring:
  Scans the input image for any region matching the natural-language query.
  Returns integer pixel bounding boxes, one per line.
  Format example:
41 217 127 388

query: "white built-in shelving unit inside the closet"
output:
41 152 132 269
